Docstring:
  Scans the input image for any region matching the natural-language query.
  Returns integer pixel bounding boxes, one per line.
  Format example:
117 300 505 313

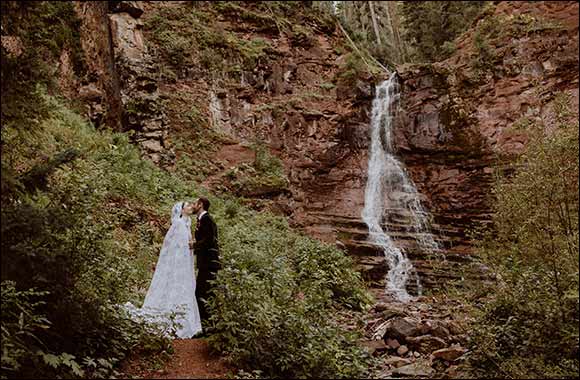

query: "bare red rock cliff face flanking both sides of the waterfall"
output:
135 2 578 285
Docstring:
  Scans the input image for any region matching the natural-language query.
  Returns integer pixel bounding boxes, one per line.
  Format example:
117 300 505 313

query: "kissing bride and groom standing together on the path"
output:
125 197 221 339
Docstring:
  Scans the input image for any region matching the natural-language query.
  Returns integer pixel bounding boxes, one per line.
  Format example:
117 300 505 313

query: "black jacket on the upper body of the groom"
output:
193 212 221 272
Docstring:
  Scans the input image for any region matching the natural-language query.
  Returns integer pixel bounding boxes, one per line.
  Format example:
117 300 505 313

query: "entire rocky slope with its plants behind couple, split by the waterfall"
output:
70 1 578 285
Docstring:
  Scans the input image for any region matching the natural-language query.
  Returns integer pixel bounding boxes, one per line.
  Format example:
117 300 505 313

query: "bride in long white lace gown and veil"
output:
125 202 202 339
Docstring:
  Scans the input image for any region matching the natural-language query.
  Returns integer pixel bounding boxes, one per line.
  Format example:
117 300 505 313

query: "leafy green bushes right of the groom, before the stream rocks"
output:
210 211 369 378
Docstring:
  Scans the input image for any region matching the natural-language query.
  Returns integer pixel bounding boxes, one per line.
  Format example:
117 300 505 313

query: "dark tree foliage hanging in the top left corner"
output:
1 1 83 197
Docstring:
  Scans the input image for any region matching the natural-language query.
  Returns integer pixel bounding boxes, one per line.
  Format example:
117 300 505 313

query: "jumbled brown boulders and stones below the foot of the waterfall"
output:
360 289 469 378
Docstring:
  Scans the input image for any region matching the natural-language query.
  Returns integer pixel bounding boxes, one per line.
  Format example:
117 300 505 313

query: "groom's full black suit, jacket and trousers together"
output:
193 212 221 319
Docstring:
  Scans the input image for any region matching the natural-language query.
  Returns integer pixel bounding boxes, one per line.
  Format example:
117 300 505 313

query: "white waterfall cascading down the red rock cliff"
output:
362 73 439 302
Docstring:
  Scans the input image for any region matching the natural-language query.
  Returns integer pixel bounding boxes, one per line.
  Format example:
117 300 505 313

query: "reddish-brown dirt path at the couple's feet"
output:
123 339 234 379
